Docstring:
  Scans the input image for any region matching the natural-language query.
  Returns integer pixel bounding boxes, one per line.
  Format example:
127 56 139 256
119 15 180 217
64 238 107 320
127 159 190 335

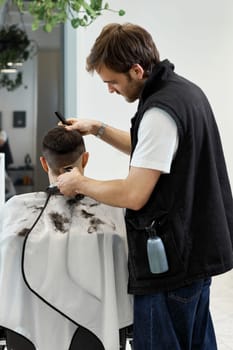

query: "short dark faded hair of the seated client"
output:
42 126 86 174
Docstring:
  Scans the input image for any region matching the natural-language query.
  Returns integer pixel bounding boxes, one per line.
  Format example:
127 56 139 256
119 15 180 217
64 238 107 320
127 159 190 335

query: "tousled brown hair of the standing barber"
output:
86 23 160 75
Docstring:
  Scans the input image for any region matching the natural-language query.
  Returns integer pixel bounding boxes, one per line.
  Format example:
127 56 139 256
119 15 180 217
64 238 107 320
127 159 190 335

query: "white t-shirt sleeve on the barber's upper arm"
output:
130 107 178 173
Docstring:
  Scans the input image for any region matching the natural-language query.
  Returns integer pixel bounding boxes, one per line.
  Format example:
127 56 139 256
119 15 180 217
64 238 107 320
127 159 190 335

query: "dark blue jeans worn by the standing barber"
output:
134 278 217 350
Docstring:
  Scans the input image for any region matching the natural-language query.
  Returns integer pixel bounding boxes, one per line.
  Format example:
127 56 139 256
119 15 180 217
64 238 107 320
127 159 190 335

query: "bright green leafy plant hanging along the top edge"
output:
0 0 125 32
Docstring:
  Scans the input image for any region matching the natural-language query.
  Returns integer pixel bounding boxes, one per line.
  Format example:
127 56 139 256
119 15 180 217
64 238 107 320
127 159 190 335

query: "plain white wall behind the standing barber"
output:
71 0 233 184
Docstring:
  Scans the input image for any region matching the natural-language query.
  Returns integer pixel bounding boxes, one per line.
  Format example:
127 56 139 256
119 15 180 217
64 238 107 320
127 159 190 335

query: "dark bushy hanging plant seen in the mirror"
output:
0 25 32 91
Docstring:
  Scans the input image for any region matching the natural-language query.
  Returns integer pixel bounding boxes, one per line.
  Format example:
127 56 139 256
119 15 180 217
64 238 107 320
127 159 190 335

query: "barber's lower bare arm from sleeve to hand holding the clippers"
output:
57 167 161 210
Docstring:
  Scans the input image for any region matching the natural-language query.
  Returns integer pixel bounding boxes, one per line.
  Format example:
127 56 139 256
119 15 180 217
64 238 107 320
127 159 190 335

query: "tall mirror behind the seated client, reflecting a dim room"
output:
0 8 64 193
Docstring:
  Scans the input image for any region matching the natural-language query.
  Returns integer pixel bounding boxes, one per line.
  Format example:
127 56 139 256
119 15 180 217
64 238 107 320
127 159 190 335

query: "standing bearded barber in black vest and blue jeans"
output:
58 24 233 350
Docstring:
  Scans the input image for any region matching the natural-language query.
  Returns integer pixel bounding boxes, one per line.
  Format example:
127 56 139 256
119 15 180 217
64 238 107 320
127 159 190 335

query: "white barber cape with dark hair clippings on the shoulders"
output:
0 192 133 350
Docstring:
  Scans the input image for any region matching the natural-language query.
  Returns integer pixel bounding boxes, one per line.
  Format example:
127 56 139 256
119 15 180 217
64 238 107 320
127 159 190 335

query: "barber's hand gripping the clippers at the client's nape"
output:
56 168 82 197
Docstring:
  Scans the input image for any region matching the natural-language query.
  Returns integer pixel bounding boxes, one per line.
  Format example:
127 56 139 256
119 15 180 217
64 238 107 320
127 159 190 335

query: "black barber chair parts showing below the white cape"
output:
4 326 133 350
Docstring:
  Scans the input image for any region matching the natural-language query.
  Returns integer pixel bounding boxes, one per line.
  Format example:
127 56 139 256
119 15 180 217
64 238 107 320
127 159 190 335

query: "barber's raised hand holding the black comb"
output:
65 118 101 136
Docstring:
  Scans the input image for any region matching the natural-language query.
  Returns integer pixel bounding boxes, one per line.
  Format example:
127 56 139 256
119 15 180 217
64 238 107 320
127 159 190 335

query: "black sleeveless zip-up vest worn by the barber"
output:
126 60 233 294
